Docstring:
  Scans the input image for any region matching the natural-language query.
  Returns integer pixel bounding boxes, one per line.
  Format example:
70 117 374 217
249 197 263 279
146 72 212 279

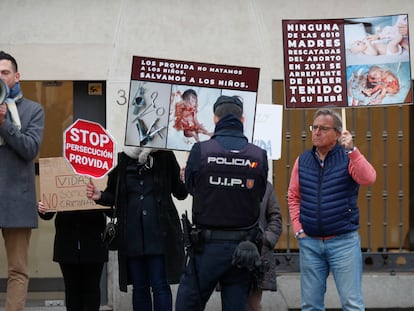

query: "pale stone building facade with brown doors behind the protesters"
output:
0 0 414 310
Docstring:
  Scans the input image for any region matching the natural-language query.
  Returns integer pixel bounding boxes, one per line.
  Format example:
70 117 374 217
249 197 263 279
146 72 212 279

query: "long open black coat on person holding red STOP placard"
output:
96 151 188 292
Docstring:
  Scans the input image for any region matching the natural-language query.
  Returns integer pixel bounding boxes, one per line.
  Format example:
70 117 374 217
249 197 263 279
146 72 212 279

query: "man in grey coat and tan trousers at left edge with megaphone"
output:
0 51 44 311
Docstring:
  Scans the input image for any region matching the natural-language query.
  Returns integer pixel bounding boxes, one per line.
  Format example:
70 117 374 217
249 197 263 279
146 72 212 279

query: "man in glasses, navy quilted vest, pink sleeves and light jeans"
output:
288 108 376 311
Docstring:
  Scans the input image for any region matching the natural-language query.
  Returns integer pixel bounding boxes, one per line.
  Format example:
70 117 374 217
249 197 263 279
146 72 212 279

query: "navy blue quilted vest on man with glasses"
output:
299 145 359 237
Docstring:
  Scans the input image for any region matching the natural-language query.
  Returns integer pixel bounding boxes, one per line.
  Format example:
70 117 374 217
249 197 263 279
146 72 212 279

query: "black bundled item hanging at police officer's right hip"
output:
232 241 261 271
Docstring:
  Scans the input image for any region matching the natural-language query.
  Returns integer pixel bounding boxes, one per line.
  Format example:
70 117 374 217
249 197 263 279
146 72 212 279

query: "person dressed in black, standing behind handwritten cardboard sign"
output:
38 206 108 311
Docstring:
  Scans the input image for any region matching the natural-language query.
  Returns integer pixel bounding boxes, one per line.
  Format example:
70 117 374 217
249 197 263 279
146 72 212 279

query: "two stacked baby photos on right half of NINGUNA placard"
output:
344 14 412 106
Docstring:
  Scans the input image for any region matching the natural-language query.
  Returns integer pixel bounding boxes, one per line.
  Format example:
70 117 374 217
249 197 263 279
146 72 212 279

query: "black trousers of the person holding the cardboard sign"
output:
59 262 104 311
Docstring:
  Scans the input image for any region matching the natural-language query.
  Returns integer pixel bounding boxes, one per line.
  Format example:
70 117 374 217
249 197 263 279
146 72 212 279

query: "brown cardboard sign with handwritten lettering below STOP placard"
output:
39 157 110 212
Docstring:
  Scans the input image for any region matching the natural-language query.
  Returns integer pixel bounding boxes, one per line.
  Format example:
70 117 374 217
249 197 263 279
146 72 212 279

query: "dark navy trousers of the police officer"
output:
175 241 249 311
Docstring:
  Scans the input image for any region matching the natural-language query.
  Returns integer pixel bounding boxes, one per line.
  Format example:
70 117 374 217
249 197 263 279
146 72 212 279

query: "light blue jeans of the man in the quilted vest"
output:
299 231 365 311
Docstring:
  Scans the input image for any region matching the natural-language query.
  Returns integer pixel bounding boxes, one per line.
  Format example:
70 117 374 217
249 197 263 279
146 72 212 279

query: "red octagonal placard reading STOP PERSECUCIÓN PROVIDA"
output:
63 119 115 178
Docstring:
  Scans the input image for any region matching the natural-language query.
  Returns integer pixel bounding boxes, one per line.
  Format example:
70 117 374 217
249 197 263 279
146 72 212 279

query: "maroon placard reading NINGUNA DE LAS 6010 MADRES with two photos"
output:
282 14 412 109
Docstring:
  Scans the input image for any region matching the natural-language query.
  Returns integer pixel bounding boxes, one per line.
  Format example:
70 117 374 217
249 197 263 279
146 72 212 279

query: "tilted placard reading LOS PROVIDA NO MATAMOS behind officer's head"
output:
125 56 259 151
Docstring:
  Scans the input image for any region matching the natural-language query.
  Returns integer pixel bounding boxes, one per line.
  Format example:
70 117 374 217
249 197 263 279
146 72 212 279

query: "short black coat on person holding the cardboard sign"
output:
39 210 108 264
